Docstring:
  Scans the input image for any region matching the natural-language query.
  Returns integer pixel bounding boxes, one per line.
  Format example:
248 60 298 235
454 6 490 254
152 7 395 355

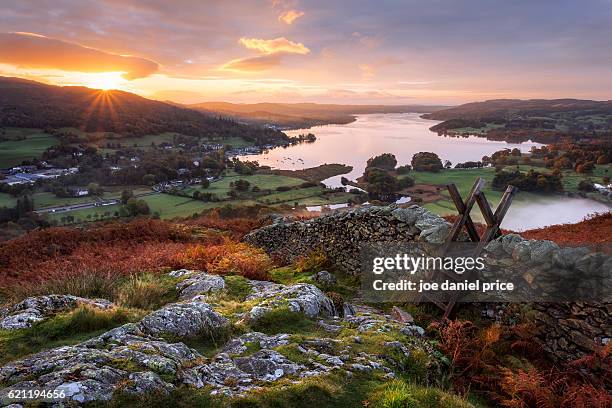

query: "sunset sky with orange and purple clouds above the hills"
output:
0 0 612 104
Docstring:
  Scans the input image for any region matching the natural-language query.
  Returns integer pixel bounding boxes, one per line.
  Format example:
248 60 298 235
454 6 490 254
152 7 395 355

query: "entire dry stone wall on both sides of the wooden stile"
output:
245 205 612 360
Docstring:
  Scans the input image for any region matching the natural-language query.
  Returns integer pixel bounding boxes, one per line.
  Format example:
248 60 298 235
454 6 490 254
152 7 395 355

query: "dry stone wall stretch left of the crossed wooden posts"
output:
245 205 450 274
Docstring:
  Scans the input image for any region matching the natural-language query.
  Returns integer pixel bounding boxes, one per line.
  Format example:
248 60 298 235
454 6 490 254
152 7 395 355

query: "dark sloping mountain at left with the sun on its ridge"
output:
0 77 287 143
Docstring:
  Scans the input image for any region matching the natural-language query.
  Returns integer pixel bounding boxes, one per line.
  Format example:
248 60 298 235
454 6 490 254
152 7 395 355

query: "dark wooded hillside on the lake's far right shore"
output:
423 99 612 143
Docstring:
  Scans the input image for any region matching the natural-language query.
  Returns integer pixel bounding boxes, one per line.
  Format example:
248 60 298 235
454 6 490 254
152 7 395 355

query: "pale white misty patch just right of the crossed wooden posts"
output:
502 194 610 231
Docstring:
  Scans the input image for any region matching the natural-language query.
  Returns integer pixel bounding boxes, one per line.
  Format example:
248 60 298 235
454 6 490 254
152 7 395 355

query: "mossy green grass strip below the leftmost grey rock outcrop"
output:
0 306 142 364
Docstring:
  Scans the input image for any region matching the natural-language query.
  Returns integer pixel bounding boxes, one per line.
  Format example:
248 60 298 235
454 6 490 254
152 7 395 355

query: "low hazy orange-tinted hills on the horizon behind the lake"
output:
187 102 446 128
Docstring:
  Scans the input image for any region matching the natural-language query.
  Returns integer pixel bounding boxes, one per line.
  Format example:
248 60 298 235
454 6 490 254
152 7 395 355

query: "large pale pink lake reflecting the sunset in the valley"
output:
243 113 540 187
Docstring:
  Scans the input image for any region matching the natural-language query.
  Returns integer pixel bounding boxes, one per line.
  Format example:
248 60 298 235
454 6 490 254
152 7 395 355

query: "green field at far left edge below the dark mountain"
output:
0 128 58 168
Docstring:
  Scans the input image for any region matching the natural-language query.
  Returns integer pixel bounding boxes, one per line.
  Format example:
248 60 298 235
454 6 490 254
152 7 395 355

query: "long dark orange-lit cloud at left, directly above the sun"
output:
0 32 159 80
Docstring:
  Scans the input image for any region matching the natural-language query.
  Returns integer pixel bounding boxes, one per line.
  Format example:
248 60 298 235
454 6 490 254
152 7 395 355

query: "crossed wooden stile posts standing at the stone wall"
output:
422 177 518 318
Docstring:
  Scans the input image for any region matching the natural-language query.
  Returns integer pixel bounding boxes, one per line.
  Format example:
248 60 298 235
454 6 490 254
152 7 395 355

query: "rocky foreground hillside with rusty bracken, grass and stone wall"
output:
0 206 612 408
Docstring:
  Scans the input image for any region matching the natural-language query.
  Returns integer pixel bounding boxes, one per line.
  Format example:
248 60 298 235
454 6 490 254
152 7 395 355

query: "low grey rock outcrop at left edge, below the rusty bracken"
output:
0 295 113 330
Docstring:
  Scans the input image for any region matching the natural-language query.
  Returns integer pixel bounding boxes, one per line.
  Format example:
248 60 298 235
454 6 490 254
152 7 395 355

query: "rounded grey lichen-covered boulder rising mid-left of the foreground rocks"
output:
139 301 229 337
